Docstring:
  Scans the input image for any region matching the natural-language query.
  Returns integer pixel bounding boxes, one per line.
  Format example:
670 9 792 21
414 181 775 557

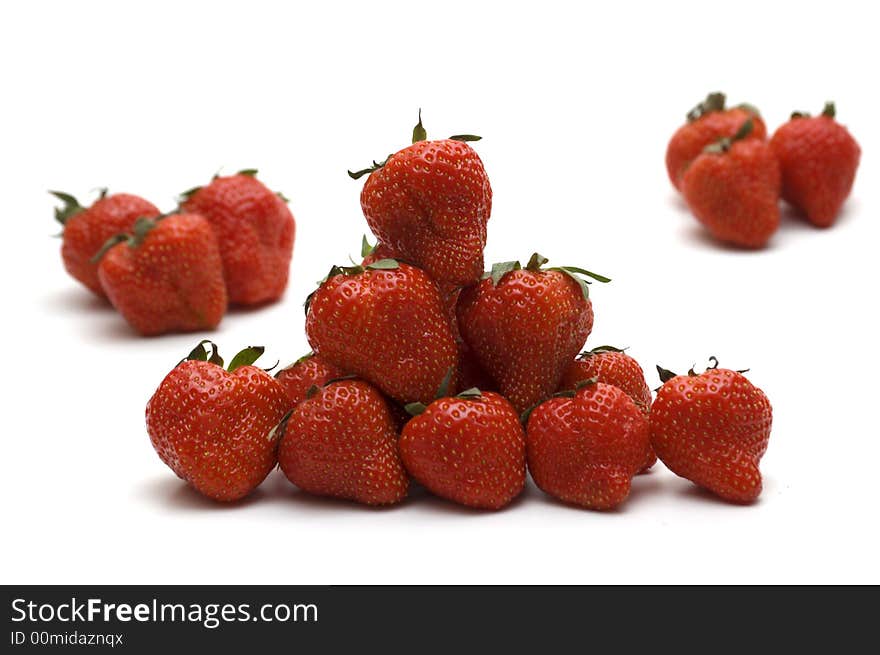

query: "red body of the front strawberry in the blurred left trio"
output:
98 214 227 336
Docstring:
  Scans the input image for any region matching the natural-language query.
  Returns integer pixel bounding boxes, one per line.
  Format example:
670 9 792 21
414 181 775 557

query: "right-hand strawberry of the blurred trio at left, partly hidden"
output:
181 170 296 305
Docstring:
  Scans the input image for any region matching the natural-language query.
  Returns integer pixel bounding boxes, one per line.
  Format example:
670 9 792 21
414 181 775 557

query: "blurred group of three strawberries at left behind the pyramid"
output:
50 170 296 336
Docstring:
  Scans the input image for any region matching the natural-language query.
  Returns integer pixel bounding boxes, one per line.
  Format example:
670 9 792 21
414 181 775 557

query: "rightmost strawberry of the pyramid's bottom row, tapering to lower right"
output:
651 357 773 503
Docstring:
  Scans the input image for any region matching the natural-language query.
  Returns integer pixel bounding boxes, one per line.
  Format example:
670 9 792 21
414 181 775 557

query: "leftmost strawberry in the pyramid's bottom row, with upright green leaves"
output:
147 341 289 501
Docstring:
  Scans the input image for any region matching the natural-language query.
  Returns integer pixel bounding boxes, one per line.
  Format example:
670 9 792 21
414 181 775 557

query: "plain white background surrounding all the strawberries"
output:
0 1 880 583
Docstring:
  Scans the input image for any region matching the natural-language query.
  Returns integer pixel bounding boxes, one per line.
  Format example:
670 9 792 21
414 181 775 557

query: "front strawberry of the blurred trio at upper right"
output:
682 120 780 248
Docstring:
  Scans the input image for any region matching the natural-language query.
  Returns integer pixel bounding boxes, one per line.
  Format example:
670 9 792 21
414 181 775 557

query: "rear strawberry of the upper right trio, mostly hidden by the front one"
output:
666 93 767 191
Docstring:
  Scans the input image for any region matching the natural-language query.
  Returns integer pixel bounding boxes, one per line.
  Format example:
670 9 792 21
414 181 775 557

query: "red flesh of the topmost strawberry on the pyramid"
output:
361 139 492 285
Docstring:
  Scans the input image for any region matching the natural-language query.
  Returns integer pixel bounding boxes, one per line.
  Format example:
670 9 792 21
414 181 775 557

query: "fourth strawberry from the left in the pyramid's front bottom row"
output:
526 382 650 509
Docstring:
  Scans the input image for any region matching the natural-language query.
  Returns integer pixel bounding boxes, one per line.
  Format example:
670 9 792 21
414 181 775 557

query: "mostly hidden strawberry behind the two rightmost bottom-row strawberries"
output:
559 346 657 471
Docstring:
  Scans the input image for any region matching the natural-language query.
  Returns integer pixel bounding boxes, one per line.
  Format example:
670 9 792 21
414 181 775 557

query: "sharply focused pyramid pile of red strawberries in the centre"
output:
146 117 771 510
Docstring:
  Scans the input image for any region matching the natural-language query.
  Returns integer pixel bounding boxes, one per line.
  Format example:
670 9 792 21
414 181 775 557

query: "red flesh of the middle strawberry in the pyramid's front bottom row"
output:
400 392 526 510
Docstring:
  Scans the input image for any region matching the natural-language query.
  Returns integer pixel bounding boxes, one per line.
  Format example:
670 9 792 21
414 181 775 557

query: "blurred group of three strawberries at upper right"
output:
666 93 861 248
